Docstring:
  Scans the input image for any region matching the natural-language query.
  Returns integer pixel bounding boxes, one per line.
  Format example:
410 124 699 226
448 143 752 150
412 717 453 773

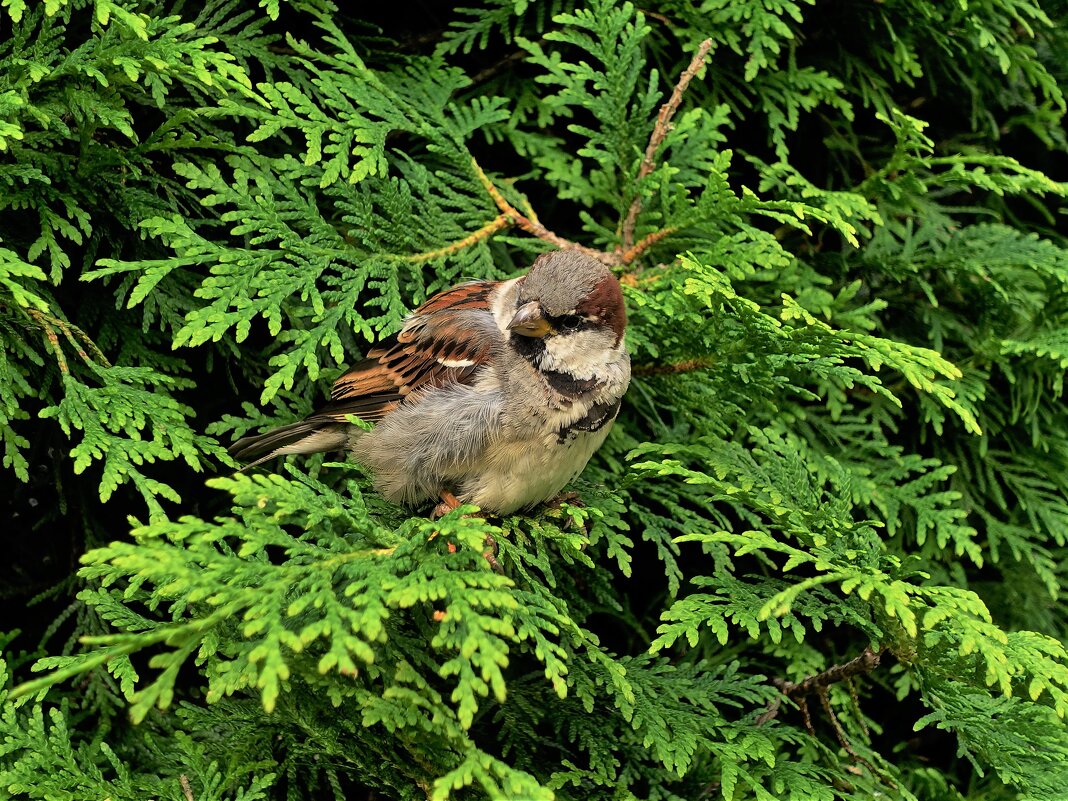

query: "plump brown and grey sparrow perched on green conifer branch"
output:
230 250 630 515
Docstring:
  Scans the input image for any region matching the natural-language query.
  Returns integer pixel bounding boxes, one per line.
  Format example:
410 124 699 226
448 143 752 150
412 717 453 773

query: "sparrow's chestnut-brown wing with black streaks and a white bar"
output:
308 281 500 422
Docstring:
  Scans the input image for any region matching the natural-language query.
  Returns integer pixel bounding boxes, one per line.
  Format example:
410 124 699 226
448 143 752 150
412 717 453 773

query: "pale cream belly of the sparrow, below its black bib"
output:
458 422 612 514
